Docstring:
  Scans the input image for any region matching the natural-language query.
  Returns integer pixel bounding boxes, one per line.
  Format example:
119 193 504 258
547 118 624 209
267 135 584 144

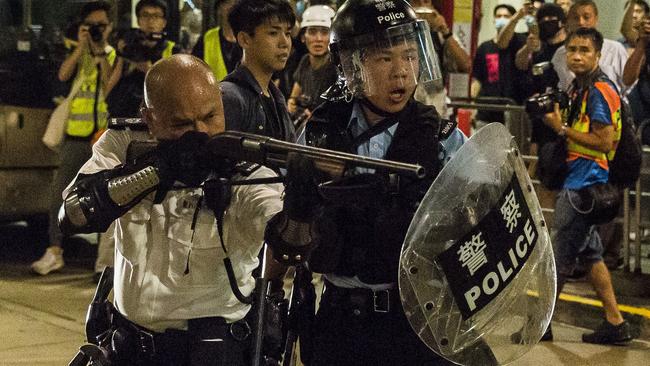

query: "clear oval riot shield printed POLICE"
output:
399 123 556 366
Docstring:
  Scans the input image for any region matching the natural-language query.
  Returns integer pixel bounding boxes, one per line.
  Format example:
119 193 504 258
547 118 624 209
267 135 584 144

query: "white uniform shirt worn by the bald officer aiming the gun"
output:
71 130 284 332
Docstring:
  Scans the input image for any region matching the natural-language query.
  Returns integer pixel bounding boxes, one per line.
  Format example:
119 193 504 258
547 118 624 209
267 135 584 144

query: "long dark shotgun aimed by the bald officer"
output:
209 131 426 178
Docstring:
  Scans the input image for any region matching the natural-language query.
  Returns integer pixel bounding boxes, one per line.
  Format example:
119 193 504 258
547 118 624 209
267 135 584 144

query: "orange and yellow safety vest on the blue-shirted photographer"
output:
567 81 622 170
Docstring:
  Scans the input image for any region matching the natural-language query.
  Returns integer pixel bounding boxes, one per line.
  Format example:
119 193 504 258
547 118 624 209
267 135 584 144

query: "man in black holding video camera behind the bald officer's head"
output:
106 0 178 118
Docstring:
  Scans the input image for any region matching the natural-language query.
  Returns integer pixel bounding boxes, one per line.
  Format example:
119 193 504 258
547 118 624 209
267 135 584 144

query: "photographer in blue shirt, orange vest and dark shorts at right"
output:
544 28 632 344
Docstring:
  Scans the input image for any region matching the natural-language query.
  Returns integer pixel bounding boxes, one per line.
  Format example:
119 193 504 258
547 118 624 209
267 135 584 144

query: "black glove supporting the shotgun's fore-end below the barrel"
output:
284 153 324 222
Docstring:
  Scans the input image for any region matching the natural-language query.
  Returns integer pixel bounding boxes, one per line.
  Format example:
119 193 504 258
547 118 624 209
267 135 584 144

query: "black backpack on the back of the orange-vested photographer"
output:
609 98 643 188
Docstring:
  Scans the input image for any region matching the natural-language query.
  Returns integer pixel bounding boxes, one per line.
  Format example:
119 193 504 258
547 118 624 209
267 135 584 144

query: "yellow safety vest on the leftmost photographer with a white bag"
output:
66 48 116 137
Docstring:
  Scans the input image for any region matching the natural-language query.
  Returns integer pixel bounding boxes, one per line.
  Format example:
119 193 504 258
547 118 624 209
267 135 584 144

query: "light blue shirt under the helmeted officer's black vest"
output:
298 102 467 291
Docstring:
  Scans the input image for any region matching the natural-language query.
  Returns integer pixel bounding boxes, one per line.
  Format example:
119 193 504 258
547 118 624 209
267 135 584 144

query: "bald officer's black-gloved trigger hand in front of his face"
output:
154 131 212 201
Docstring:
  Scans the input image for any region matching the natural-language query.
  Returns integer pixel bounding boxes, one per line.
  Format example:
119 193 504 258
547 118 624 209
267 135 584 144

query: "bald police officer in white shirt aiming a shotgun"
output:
60 55 314 365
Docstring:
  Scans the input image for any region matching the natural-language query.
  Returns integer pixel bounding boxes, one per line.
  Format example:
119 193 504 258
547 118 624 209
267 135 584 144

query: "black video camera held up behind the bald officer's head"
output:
117 28 166 62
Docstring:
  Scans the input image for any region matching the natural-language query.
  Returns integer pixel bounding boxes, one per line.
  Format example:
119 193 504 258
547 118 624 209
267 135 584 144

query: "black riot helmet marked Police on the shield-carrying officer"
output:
329 0 441 96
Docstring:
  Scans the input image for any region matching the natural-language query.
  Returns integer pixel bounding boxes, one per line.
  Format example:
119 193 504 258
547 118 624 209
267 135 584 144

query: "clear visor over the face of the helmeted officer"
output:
339 20 442 98
